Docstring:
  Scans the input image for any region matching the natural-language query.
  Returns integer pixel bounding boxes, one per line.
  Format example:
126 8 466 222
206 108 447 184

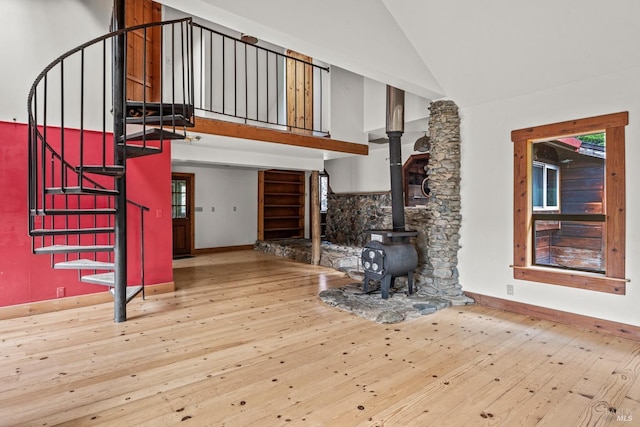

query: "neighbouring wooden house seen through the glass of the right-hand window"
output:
531 137 606 272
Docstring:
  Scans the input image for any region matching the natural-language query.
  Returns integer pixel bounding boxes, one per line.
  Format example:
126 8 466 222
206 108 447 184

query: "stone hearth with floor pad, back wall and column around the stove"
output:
256 100 473 323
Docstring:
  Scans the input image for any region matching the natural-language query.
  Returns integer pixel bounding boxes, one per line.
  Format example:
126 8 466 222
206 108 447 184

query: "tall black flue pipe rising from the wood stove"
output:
386 85 405 231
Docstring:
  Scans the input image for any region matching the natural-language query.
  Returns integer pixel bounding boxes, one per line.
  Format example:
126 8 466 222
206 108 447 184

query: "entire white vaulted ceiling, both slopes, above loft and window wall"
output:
160 0 640 107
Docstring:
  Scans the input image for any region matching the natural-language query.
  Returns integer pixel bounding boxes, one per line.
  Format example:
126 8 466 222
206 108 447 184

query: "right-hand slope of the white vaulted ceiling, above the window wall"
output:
383 0 640 106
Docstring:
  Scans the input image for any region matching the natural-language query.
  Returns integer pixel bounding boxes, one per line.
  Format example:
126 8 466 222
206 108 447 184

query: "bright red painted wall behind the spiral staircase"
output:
0 121 173 306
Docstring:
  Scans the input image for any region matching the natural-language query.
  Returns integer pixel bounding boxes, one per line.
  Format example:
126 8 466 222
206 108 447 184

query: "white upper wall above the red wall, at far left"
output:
0 0 113 129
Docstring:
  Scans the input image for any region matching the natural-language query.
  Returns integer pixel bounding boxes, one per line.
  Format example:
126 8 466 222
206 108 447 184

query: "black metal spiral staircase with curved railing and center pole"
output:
28 16 193 322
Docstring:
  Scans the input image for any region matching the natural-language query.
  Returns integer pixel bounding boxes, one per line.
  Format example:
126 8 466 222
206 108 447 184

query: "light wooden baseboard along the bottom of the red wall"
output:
0 281 176 320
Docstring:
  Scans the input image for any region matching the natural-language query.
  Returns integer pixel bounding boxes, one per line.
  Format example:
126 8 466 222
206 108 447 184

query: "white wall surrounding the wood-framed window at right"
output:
459 69 640 325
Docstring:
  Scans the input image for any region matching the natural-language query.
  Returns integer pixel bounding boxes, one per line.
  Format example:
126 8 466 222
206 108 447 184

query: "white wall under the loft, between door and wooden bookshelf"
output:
172 165 258 249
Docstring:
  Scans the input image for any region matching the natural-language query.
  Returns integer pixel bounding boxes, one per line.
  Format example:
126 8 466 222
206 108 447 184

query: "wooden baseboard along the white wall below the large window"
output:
465 292 640 341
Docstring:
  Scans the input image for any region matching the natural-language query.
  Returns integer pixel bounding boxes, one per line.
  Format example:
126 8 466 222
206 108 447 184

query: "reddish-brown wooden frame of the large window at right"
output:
511 111 629 295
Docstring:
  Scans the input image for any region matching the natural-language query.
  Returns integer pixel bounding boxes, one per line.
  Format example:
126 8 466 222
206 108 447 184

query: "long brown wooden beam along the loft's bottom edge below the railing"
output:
191 117 369 156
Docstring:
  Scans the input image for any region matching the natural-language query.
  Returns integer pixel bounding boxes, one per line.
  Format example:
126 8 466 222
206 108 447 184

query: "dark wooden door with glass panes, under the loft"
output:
171 173 194 257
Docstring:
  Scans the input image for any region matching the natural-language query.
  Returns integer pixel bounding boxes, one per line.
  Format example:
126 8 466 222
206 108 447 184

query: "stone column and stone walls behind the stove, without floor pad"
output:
258 101 473 304
